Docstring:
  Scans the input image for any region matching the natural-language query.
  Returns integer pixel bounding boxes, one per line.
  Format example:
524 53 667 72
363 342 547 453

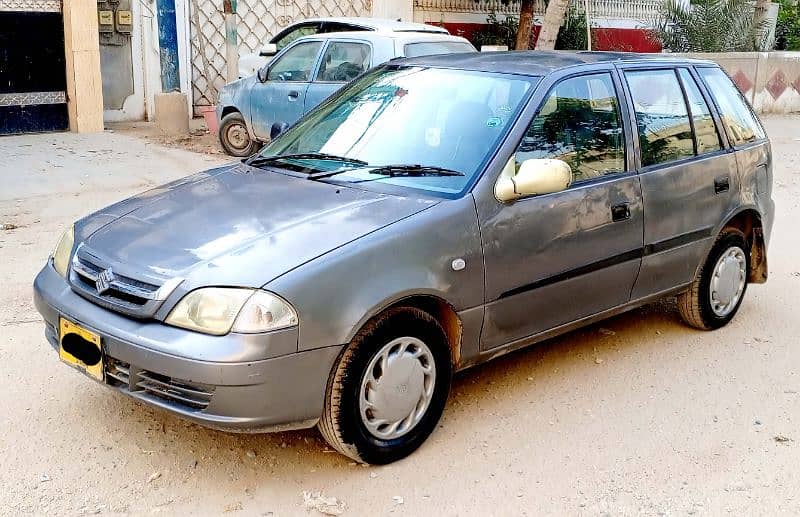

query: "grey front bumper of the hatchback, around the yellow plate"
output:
34 264 342 432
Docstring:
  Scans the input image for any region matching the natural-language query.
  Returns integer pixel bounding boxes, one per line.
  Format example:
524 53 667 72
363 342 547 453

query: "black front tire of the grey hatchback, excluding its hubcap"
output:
318 307 452 465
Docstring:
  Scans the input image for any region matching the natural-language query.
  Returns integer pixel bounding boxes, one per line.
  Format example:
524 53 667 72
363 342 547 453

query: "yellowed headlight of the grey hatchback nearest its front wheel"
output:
166 287 297 336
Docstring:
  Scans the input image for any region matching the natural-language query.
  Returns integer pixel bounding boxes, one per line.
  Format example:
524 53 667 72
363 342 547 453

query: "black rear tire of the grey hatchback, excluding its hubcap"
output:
678 228 750 330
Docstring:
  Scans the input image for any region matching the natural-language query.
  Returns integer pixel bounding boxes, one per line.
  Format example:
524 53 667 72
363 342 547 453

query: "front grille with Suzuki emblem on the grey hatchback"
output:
69 246 180 318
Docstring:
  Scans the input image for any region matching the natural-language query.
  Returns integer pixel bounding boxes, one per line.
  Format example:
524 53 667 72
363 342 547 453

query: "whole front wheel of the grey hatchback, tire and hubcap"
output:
319 307 452 464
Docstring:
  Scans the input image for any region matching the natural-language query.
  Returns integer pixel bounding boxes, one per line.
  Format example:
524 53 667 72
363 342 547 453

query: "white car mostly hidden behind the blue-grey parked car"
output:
239 17 449 79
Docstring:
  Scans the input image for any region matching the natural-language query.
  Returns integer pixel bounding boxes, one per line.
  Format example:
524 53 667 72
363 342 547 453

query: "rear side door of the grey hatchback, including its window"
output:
623 67 738 299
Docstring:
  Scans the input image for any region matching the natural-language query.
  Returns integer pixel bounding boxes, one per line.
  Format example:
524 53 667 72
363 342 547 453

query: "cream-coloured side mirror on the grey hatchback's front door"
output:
494 156 572 201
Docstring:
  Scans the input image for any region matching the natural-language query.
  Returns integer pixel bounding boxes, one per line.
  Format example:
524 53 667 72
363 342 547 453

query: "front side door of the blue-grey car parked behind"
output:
250 40 323 140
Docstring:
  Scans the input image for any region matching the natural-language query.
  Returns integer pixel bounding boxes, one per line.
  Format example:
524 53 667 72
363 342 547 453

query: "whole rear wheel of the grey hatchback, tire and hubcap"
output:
678 229 750 330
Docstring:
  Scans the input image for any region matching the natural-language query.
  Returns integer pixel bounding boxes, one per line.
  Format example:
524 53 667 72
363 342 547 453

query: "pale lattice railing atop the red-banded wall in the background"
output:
414 0 662 20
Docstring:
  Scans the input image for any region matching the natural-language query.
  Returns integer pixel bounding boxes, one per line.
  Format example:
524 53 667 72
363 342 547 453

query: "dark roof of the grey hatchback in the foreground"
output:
392 50 714 75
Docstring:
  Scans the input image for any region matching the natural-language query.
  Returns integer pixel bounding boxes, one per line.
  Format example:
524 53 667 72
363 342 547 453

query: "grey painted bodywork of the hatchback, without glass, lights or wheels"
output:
34 52 774 429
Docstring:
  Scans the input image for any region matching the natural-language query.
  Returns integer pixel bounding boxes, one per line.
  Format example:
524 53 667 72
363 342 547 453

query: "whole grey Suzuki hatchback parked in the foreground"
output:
34 52 774 463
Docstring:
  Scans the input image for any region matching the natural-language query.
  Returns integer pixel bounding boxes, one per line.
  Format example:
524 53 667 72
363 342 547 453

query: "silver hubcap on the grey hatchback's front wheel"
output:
359 337 436 440
